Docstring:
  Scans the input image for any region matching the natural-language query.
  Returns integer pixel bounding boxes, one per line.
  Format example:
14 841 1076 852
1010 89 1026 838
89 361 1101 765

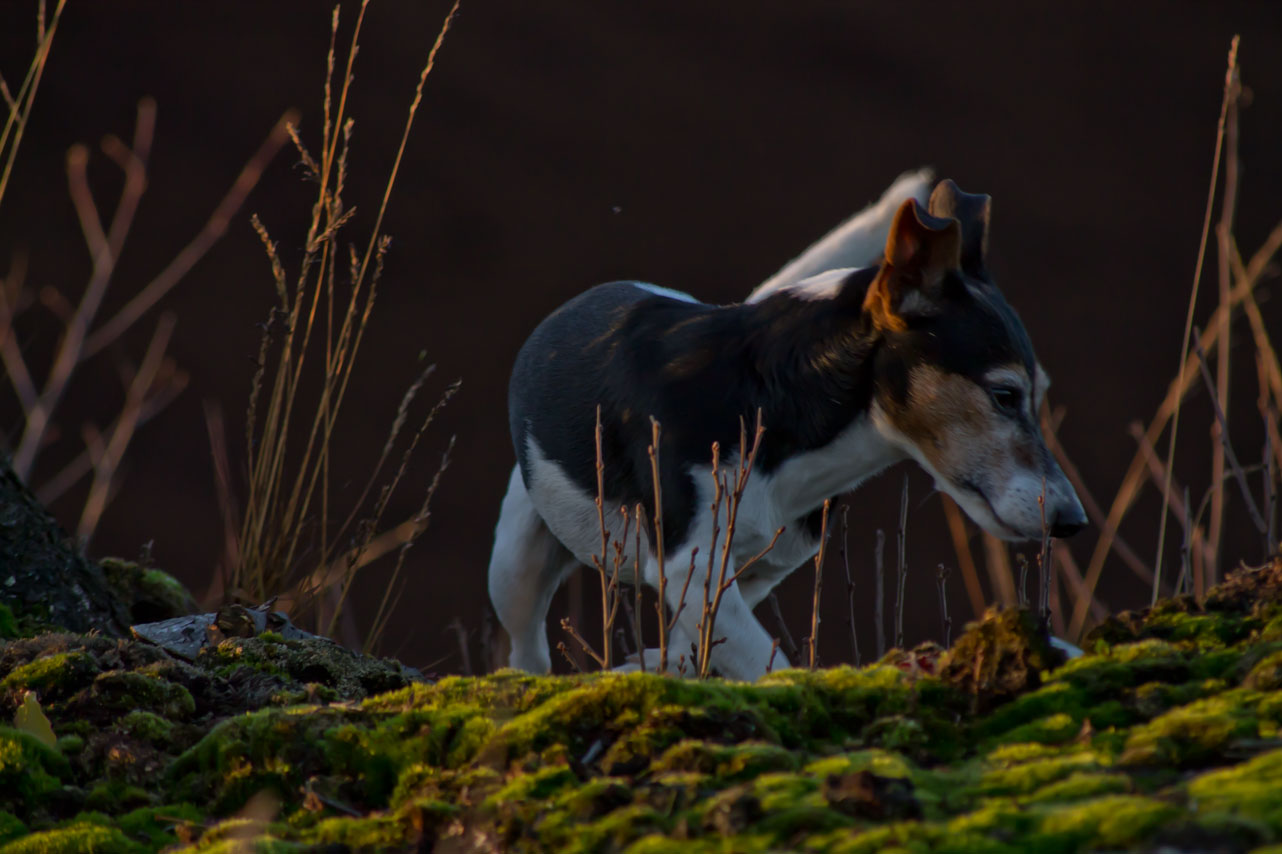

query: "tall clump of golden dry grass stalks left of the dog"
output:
232 0 458 631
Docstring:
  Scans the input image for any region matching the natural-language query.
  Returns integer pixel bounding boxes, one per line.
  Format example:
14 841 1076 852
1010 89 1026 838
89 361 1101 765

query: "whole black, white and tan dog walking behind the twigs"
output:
490 173 1086 680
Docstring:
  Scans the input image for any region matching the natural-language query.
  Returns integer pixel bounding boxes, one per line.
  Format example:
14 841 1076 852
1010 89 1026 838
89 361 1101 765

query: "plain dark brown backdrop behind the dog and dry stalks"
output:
0 0 1282 671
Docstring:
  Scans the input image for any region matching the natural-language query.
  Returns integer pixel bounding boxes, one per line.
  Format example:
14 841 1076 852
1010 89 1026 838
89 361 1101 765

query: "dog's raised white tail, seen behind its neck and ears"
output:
747 168 935 303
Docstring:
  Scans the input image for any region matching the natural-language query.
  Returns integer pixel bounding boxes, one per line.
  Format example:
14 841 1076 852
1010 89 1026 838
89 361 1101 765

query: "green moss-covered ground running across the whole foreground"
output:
0 562 1282 854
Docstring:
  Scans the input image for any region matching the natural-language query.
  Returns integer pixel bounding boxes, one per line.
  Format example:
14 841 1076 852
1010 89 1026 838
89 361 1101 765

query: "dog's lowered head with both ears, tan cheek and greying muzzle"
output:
863 181 1086 540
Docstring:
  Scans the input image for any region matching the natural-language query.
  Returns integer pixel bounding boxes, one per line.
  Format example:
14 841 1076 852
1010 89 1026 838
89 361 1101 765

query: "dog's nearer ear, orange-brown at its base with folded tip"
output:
864 199 962 331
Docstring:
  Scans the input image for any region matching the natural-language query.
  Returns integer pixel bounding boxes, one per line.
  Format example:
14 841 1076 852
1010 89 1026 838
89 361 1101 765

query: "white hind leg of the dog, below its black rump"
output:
488 467 578 673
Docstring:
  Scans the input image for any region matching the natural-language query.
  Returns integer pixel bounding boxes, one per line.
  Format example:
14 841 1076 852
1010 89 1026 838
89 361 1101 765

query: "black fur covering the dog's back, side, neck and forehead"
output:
508 269 1033 548
